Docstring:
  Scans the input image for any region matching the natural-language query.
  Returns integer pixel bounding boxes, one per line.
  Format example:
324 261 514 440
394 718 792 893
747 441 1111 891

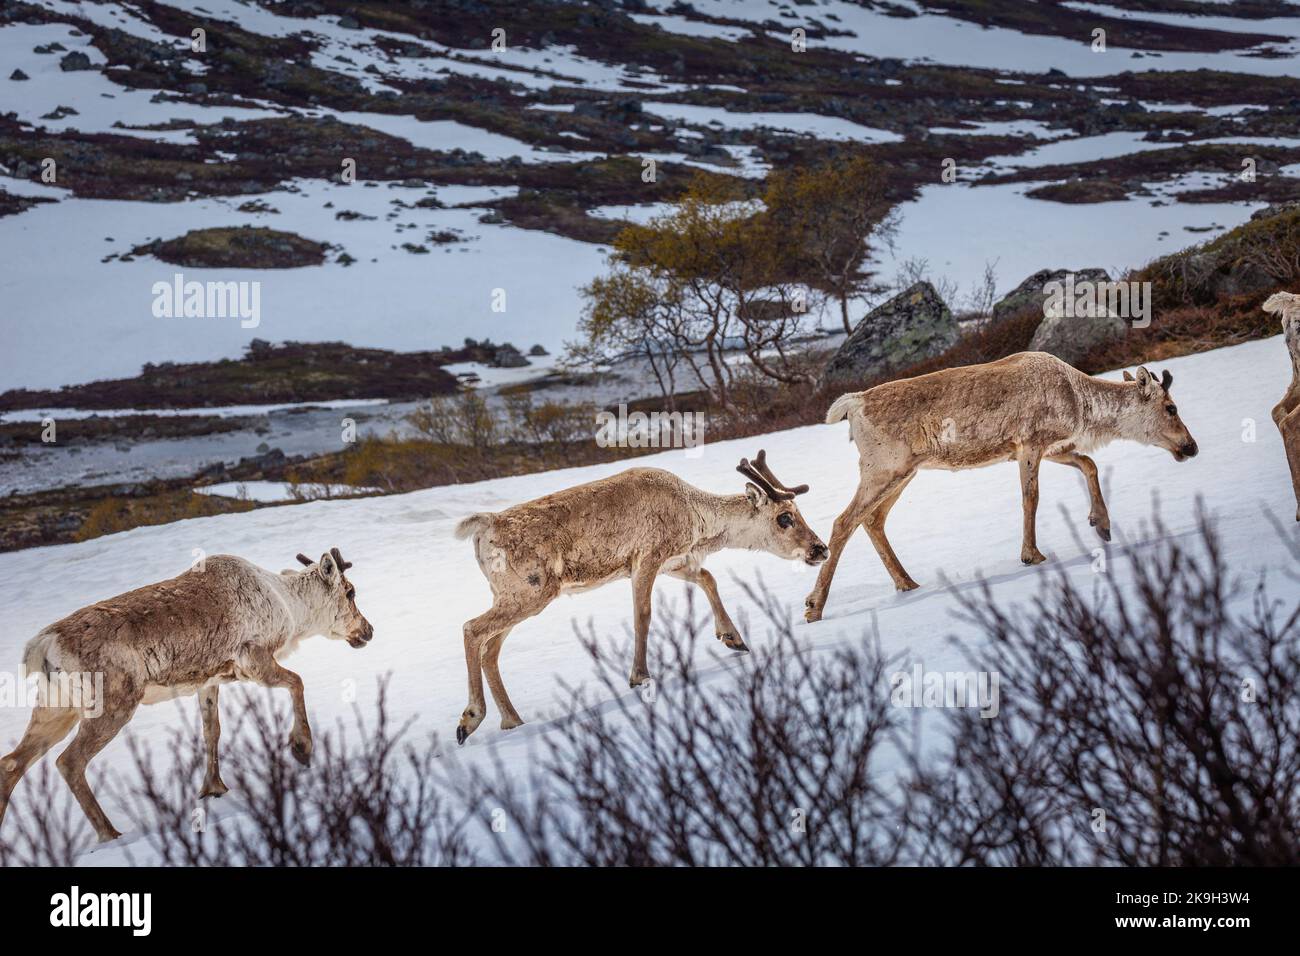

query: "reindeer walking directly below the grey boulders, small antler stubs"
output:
805 352 1197 620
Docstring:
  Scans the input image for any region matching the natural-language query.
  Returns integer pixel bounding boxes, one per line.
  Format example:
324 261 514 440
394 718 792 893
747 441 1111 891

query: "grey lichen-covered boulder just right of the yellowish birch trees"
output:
820 282 957 386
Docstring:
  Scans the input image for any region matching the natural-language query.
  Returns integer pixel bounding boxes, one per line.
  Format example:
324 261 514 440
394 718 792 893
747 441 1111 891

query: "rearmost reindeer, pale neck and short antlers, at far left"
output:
0 548 374 843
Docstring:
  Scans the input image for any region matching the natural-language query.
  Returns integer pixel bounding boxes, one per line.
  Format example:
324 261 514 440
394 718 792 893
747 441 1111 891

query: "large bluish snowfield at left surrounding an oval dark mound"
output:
0 178 603 388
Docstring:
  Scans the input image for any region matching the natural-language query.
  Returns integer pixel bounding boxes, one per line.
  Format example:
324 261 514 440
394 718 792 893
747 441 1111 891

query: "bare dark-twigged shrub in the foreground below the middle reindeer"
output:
464 591 902 866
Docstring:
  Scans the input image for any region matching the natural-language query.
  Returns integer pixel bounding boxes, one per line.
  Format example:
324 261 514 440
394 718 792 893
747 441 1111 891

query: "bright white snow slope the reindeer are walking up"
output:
0 338 1300 864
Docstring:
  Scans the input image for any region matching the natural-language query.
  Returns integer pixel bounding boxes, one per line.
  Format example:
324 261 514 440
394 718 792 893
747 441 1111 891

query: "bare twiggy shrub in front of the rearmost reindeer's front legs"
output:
111 682 473 866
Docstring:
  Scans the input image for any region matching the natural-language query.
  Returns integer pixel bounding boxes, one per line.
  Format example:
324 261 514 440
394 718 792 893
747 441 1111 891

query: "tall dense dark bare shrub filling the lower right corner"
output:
906 515 1300 866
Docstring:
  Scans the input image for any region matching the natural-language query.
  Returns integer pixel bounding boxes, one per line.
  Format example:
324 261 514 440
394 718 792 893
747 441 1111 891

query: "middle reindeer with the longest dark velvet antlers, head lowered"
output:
456 451 827 744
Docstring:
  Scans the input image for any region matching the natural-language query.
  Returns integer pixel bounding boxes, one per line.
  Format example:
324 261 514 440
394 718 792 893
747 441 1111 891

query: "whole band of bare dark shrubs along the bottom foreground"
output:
0 520 1300 866
